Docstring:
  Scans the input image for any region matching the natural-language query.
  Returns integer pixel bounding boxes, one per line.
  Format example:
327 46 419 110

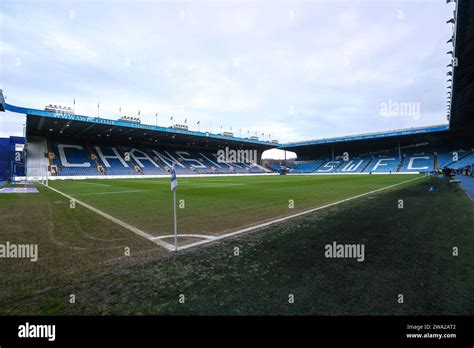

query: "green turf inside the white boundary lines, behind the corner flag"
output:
46 175 416 239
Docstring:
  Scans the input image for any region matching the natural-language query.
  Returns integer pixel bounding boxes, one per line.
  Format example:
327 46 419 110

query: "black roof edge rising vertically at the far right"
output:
448 0 474 130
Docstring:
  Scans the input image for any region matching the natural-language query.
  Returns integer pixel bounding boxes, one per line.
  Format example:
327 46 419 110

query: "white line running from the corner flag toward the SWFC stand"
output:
172 176 424 250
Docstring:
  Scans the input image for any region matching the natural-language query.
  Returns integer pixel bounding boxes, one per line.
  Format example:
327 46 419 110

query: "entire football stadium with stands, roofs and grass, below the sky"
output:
0 0 474 330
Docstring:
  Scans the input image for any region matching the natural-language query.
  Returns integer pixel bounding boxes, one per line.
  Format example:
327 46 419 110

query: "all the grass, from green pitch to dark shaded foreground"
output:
0 175 474 315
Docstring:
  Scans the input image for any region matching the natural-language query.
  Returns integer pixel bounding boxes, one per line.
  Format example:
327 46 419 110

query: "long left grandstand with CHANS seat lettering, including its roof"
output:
0 92 277 181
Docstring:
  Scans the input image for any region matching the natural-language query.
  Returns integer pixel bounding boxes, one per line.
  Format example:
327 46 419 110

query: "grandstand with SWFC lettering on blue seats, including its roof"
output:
280 125 474 175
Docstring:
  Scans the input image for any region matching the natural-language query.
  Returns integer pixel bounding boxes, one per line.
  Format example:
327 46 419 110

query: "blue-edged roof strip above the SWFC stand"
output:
280 124 449 150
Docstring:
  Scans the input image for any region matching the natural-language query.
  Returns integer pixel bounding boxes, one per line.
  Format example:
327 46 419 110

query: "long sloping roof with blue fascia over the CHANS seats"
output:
0 91 278 151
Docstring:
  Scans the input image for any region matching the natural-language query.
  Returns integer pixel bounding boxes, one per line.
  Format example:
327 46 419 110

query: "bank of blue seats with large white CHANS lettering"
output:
45 141 265 176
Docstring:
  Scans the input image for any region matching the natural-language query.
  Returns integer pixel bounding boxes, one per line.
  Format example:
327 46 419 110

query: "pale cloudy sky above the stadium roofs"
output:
0 0 454 148
